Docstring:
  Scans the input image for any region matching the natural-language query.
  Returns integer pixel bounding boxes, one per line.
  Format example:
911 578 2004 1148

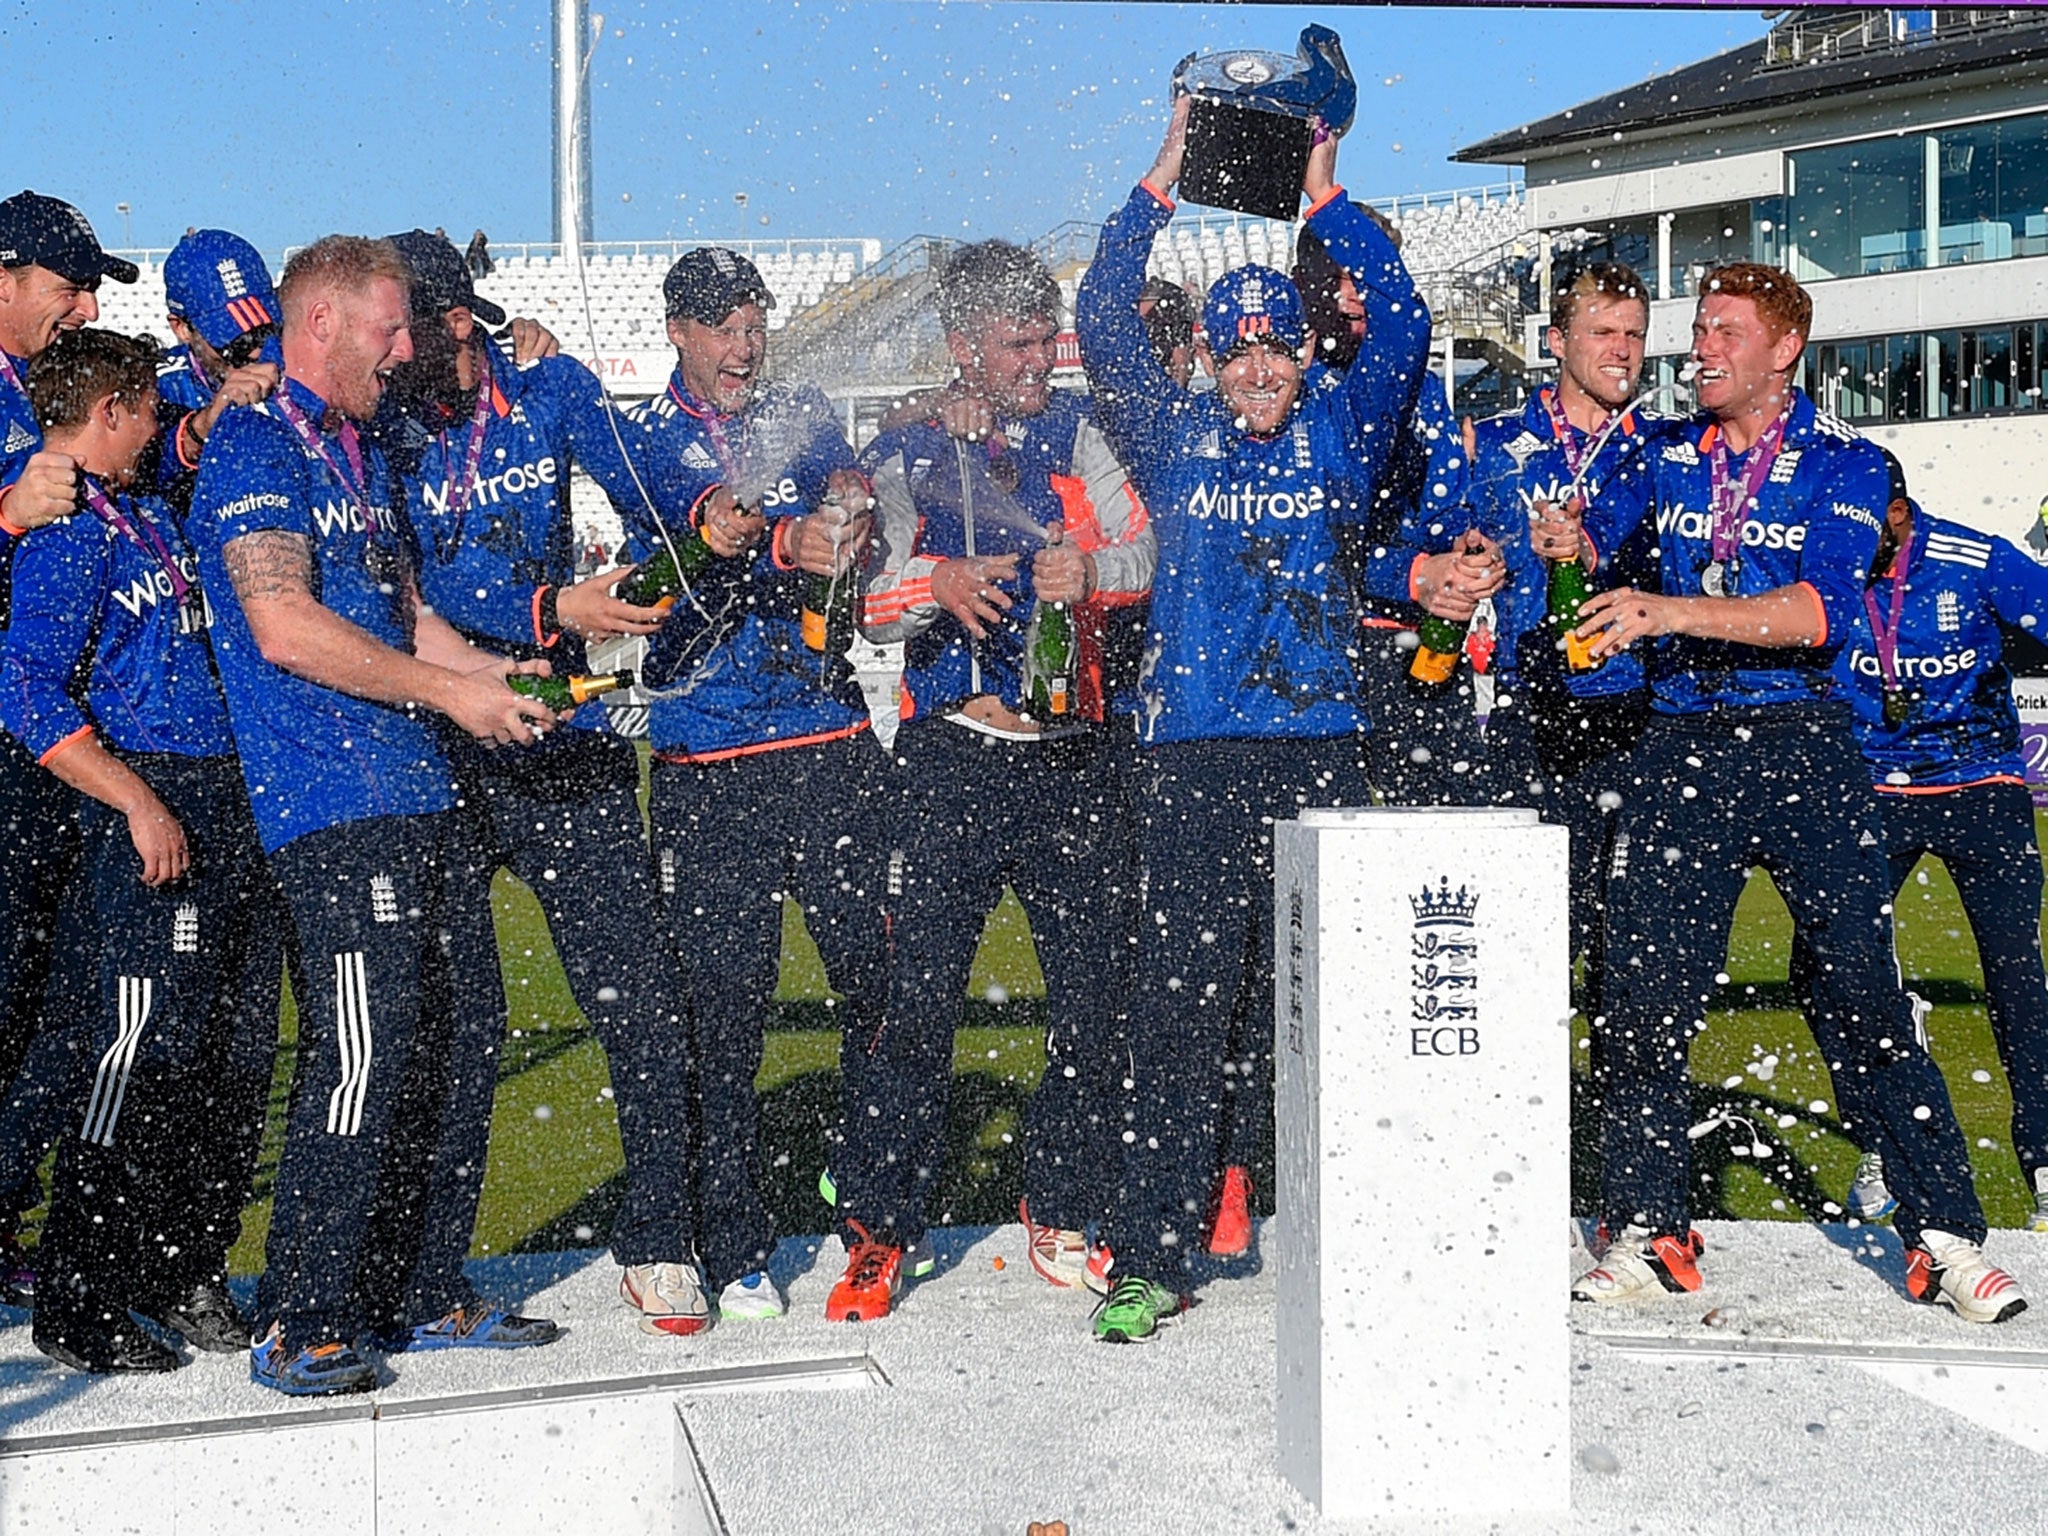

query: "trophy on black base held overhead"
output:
1174 27 1358 219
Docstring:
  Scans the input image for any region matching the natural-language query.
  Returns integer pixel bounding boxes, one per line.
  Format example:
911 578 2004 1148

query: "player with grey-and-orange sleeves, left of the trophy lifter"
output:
825 240 1155 1319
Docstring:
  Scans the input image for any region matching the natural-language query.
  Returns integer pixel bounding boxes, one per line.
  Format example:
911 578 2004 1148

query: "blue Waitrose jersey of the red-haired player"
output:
1585 389 1890 715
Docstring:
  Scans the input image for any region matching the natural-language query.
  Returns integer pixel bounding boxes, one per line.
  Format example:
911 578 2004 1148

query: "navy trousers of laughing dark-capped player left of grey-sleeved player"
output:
649 733 889 1288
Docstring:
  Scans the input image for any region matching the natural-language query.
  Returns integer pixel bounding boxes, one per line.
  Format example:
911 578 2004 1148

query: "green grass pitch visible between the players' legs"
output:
203 819 2032 1272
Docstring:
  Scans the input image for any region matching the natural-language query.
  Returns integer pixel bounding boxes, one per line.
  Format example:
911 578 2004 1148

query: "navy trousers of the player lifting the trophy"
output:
1102 737 1364 1276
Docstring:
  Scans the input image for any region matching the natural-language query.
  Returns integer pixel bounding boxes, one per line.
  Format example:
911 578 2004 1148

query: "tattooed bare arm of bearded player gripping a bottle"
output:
221 528 555 741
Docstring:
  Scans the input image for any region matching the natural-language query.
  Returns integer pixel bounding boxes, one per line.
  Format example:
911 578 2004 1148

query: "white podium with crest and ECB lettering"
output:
1274 809 1571 1518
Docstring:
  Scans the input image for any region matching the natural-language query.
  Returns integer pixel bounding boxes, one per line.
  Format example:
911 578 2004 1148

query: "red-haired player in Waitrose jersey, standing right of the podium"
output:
1532 262 2025 1323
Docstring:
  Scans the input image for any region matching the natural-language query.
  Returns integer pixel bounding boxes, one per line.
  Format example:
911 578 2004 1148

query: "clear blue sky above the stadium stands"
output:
0 0 1763 252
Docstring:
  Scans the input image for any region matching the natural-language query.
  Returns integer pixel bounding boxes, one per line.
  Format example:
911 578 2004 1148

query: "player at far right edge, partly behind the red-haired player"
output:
1794 455 2048 1233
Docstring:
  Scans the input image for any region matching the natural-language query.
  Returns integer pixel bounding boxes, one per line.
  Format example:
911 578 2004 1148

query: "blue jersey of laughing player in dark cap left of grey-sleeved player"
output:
627 373 868 760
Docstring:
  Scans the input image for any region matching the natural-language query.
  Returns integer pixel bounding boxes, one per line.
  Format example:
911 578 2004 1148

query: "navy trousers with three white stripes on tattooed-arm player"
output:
256 811 506 1352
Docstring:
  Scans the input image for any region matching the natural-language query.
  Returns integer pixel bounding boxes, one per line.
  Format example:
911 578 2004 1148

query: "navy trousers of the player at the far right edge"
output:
1794 784 2048 1190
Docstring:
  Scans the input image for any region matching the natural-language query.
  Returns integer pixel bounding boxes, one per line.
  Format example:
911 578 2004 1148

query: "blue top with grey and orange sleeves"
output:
860 389 1155 717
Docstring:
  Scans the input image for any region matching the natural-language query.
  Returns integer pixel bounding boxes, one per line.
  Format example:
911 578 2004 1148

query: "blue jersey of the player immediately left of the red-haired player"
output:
1425 387 1663 698
